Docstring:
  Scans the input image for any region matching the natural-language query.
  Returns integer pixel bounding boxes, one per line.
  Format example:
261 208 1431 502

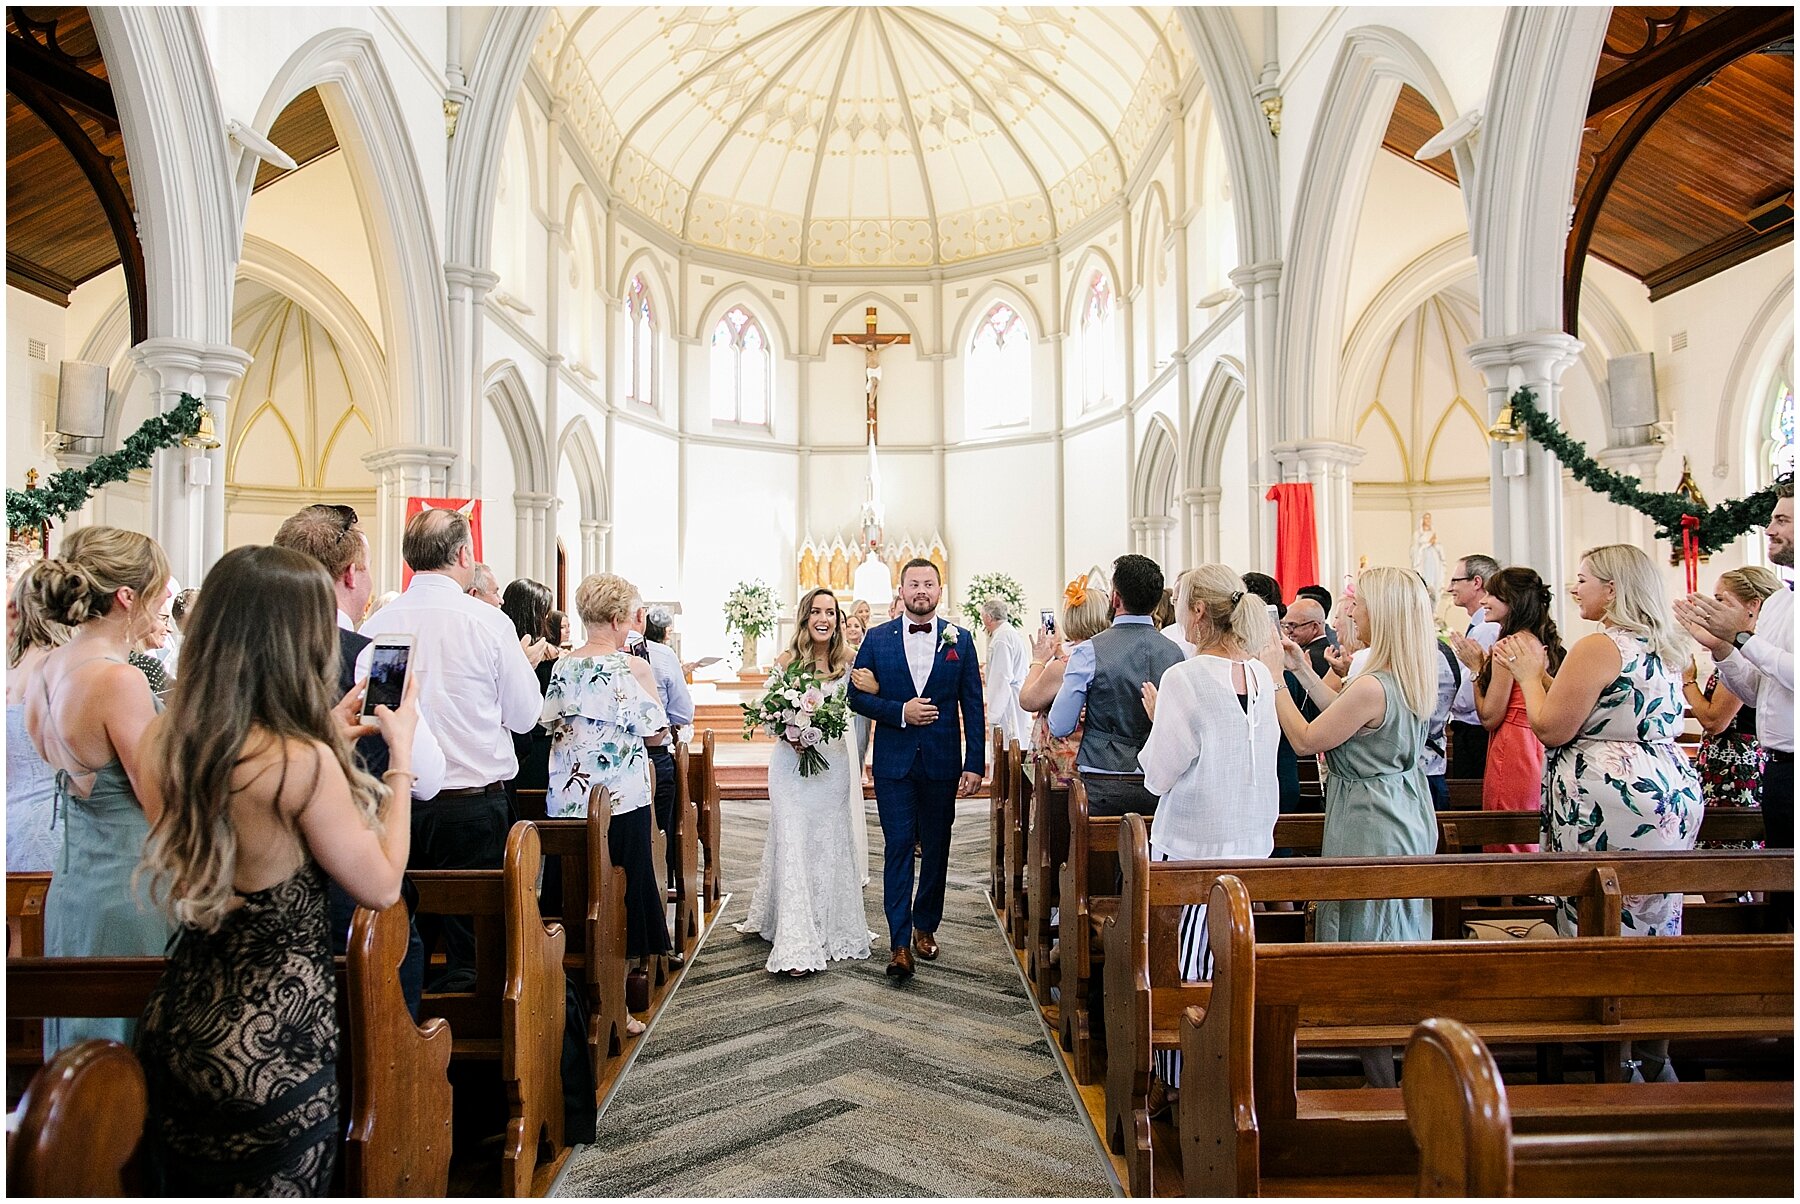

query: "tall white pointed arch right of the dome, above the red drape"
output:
1273 25 1480 443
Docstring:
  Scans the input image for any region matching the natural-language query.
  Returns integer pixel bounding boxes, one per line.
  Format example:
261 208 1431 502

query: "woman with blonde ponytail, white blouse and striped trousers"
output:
1138 565 1285 1110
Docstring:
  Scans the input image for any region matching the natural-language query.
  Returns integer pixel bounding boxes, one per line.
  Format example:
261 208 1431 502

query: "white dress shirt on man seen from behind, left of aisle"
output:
358 572 544 790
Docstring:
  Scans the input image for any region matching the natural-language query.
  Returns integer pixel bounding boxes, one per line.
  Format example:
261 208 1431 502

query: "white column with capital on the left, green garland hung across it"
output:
130 338 250 587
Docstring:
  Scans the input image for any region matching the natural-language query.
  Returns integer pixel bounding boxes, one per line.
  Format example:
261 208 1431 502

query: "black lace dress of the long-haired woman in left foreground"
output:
137 864 338 1197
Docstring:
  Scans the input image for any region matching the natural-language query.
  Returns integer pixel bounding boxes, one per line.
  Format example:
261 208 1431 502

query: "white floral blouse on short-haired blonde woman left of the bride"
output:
542 651 668 819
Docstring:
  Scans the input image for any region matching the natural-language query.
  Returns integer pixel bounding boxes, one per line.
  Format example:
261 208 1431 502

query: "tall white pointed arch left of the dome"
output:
238 29 452 445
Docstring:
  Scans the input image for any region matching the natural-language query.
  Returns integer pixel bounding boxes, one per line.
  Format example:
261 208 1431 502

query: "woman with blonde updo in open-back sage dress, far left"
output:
25 527 169 1060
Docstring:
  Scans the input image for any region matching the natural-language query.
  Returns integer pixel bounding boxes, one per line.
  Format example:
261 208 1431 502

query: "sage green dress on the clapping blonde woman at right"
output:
1314 671 1438 941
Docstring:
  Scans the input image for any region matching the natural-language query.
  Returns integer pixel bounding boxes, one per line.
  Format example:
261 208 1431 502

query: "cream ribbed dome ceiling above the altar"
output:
535 7 1192 266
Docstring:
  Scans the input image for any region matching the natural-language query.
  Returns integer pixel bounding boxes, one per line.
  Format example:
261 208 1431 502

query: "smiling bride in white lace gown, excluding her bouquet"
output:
738 589 869 977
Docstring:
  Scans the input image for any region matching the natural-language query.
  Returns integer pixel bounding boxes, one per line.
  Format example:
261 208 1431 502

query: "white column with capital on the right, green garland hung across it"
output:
1469 331 1582 610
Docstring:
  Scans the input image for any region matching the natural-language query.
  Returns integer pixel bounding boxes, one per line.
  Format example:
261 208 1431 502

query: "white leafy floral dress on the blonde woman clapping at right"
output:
1543 628 1705 936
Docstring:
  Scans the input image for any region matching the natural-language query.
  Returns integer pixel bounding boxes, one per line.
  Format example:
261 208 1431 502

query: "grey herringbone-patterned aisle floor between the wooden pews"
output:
556 799 1116 1197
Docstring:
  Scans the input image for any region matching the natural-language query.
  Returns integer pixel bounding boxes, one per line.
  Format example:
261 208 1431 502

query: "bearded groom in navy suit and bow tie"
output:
850 560 986 983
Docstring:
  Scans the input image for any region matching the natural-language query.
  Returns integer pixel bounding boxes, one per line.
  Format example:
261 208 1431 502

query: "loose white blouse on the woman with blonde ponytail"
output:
1138 655 1282 860
